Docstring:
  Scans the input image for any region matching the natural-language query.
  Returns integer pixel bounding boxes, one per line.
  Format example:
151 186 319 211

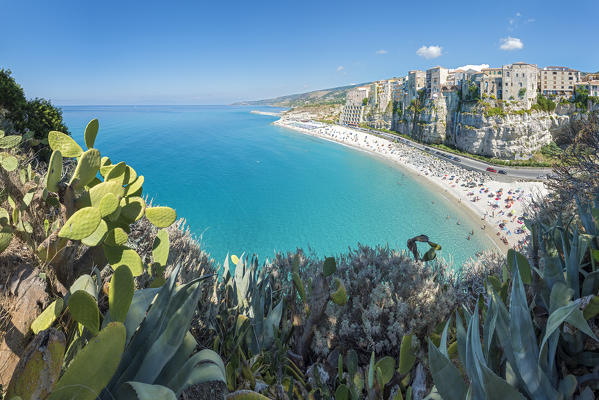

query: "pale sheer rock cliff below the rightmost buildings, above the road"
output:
394 92 571 159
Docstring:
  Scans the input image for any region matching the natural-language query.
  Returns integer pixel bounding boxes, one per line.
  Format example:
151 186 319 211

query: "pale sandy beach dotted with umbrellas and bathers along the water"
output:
274 118 547 250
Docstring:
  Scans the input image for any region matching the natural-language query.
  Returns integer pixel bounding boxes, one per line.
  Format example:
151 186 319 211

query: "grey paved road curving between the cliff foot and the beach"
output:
352 127 552 180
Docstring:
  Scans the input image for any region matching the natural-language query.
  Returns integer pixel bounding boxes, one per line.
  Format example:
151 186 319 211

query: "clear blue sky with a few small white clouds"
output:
0 0 599 105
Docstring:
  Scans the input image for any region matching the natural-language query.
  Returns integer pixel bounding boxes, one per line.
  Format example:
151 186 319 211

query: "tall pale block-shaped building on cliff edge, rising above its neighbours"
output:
501 62 538 108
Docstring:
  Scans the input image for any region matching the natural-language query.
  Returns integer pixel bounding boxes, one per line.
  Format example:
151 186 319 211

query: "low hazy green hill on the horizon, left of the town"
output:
233 83 367 108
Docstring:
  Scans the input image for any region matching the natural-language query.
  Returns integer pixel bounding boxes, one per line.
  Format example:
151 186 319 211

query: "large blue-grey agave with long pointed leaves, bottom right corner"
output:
429 247 599 399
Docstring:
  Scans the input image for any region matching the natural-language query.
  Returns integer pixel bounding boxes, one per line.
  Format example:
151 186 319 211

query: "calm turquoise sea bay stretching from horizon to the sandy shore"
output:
63 106 493 265
